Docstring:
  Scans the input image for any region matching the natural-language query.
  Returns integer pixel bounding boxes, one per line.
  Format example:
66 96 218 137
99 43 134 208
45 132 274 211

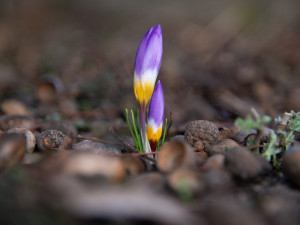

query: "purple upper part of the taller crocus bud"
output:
134 25 163 79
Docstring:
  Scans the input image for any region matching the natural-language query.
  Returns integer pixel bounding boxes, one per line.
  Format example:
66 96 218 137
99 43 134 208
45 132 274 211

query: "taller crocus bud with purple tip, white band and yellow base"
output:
133 25 163 107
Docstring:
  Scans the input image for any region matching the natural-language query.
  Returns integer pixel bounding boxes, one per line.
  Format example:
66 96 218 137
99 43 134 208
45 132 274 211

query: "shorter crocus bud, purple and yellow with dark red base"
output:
147 81 165 152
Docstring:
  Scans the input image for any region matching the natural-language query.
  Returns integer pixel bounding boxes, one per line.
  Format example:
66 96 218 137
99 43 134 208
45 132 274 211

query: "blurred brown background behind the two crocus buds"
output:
0 0 300 136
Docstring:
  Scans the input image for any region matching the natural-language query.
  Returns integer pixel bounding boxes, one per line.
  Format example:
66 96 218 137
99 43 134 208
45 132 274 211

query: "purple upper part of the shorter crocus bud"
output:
148 81 165 127
